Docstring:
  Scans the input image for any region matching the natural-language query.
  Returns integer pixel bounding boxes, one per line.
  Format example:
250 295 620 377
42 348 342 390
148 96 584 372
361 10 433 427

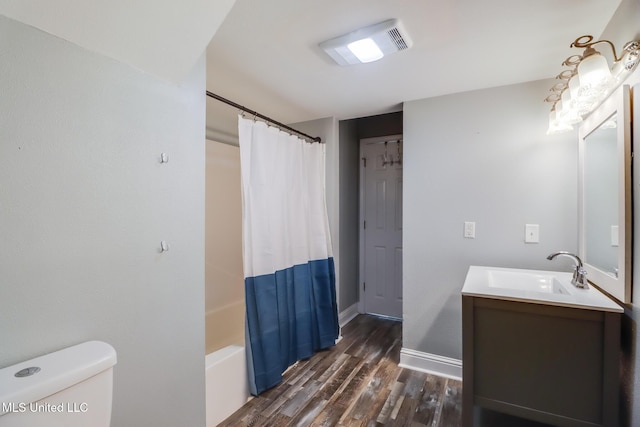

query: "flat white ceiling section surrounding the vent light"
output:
207 0 620 140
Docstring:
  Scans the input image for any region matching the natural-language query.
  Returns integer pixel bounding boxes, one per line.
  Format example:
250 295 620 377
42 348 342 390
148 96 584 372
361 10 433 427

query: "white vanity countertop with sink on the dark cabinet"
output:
462 265 624 313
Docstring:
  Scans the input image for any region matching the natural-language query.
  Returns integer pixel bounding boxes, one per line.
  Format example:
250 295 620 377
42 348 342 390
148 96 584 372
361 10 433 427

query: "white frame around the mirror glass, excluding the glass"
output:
578 85 633 304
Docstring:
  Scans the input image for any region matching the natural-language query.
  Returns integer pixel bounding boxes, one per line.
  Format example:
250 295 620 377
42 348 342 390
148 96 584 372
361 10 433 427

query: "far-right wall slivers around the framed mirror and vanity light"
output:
602 0 640 426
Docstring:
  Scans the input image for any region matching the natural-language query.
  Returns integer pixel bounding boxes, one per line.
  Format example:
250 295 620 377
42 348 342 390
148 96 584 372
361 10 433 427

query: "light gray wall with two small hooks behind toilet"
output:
0 16 205 427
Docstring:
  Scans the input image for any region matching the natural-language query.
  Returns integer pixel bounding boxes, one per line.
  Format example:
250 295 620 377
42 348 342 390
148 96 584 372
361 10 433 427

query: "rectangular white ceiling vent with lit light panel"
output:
319 19 411 65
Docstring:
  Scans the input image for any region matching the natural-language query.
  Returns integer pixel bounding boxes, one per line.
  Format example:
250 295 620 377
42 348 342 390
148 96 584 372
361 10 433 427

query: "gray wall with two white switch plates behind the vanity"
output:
403 81 578 359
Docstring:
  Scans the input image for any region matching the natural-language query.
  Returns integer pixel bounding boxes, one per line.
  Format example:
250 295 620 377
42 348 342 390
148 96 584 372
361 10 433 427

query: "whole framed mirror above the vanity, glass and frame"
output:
579 86 632 303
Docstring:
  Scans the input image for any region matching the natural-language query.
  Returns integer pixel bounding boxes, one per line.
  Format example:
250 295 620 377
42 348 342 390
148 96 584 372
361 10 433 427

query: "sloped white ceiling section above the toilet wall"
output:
0 0 234 82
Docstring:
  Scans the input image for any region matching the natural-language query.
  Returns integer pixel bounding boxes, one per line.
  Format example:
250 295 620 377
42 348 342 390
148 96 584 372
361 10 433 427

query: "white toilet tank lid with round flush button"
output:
0 341 116 415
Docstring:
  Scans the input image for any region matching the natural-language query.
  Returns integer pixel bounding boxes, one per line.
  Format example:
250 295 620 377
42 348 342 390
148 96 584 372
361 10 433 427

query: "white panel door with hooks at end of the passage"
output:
361 140 402 319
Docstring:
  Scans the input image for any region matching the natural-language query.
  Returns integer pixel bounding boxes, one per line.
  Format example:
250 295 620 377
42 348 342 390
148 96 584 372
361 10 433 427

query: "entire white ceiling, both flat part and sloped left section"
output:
0 0 620 142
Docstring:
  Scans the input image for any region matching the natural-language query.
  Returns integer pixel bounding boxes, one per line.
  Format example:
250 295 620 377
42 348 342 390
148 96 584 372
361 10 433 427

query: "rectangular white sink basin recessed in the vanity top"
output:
487 270 571 295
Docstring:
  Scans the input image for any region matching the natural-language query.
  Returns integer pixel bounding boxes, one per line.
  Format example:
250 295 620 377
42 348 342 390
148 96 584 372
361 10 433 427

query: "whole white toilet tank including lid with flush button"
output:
0 341 116 427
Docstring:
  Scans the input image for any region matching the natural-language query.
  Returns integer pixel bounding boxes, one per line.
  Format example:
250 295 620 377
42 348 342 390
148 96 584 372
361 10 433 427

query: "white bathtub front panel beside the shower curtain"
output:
205 345 250 427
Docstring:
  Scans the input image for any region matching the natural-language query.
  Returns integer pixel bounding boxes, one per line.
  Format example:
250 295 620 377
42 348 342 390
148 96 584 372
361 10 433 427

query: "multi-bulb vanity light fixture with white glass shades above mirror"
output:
545 35 640 134
